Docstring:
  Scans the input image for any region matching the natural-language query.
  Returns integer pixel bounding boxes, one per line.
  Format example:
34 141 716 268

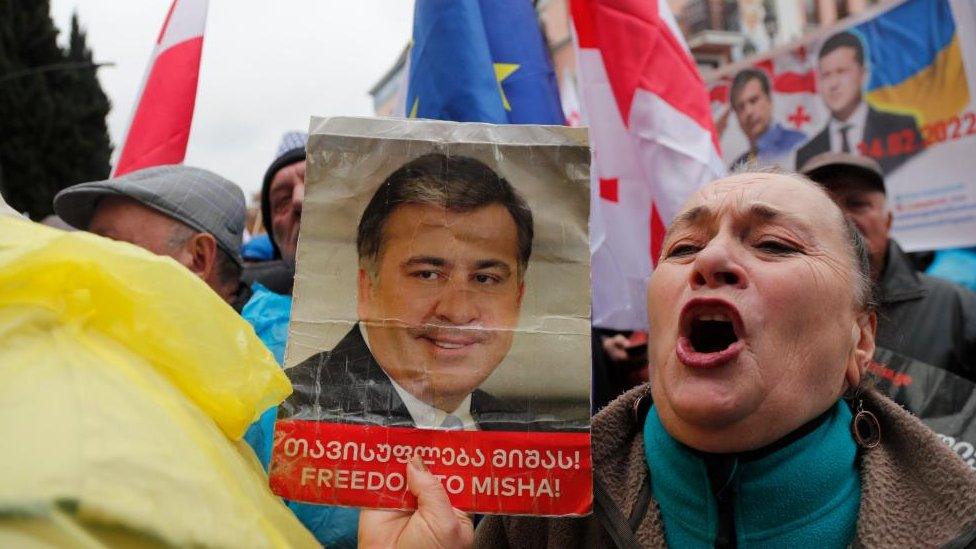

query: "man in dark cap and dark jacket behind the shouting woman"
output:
801 152 976 381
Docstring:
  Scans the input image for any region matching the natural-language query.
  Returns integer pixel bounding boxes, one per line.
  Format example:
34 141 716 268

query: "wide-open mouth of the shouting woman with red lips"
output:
675 299 744 368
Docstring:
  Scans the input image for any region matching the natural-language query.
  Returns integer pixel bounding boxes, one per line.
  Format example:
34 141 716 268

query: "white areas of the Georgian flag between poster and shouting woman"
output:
577 48 725 329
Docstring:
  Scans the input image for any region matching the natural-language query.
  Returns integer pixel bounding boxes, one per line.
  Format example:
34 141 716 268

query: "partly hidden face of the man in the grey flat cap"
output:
88 196 192 267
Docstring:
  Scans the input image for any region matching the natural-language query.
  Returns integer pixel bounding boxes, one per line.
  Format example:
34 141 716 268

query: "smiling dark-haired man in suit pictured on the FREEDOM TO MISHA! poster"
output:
284 154 558 431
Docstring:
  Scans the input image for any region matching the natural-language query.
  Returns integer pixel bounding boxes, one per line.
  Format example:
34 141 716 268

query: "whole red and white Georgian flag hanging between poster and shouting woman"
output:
571 0 725 329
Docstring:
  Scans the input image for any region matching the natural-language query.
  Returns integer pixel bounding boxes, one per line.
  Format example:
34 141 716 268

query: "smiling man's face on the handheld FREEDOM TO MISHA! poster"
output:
358 204 523 412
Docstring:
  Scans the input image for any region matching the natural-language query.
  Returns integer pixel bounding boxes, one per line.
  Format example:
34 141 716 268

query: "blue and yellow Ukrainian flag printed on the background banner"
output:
853 0 969 125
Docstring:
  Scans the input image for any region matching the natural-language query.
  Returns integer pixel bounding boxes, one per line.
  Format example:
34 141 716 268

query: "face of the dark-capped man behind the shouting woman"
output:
826 176 892 277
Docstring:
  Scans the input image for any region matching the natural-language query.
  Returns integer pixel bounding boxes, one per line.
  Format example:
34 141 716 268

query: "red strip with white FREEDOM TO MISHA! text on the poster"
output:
270 420 593 515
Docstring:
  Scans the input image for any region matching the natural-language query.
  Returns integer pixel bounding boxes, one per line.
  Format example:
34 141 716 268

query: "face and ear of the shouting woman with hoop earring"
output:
648 174 874 452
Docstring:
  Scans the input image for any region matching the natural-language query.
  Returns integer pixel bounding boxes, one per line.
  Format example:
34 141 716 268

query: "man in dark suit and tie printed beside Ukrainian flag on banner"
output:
796 31 924 174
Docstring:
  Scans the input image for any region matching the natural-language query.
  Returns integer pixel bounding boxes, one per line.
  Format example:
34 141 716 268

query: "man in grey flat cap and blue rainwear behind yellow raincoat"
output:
54 165 356 544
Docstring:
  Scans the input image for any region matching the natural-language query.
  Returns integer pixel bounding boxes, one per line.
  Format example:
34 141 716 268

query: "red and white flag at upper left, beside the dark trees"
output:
114 0 208 177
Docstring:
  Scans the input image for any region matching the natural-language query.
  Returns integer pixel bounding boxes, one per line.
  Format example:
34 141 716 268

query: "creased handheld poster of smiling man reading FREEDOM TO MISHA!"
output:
270 118 592 515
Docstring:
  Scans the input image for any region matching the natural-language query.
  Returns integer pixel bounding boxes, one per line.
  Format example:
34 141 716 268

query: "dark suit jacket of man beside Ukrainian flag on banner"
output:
796 106 925 175
